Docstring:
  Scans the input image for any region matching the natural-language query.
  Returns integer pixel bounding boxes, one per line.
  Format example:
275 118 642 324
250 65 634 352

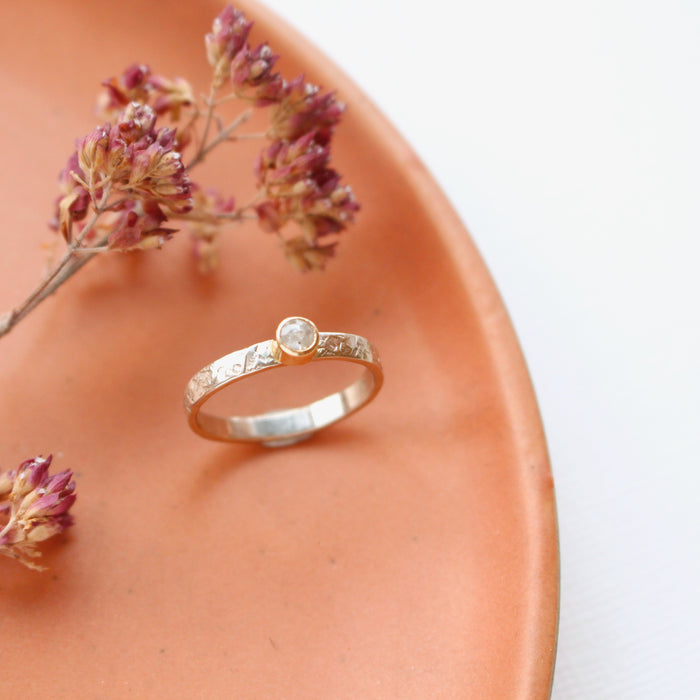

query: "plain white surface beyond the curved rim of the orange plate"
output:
267 0 700 700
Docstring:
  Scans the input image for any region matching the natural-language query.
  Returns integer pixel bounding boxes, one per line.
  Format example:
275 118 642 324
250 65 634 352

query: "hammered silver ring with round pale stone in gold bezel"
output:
185 316 384 447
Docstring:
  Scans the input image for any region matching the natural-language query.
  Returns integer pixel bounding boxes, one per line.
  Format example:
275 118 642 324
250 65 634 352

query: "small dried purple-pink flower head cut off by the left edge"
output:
0 455 75 570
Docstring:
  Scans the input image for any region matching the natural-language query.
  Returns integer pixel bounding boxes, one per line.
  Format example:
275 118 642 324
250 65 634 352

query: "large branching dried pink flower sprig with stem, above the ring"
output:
0 5 359 336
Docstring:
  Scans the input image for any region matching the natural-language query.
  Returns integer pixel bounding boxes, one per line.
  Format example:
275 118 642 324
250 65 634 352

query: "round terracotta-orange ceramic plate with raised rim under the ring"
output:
0 0 558 700
